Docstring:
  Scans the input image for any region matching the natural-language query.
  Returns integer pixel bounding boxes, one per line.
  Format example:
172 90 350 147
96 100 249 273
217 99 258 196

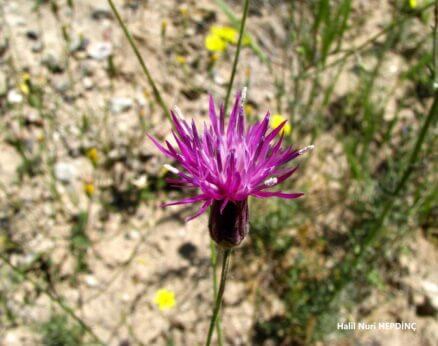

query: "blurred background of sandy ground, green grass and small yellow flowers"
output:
0 0 438 346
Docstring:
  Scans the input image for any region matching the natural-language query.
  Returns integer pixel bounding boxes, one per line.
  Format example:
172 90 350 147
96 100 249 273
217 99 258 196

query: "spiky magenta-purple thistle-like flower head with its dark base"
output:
149 92 313 247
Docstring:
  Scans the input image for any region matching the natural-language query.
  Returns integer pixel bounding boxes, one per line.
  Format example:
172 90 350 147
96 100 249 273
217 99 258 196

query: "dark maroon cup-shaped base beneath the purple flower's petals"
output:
208 199 249 248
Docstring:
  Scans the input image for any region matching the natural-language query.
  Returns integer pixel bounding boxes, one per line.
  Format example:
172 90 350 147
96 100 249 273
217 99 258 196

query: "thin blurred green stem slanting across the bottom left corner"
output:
0 254 105 345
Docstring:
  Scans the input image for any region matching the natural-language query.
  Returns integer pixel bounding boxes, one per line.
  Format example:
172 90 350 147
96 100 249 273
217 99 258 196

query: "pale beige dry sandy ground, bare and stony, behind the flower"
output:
0 0 438 346
